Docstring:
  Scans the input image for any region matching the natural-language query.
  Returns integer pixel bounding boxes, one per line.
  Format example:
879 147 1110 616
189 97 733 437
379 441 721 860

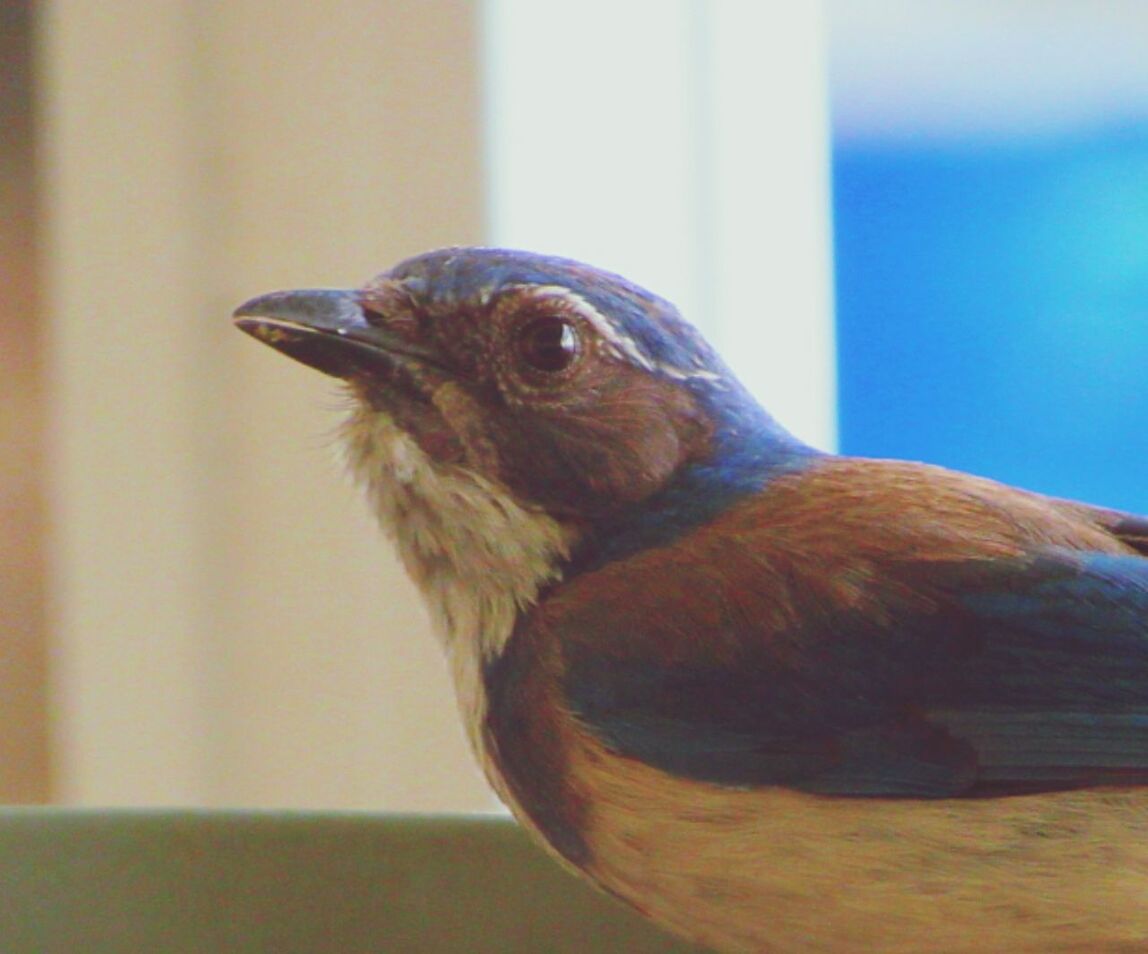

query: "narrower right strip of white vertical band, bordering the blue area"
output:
705 0 837 448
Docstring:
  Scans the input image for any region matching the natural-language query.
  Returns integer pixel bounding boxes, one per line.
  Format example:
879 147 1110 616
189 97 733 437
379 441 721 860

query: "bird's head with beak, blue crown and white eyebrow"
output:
235 248 800 585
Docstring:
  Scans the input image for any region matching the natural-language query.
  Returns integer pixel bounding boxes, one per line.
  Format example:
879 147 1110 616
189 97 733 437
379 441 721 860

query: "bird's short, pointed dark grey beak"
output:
234 288 439 379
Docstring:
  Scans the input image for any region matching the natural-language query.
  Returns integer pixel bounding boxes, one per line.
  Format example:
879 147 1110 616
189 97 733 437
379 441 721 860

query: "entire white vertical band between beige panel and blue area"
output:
484 0 836 448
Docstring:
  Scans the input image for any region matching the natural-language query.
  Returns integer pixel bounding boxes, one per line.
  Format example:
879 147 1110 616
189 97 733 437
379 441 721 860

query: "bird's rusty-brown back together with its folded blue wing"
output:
522 460 1148 796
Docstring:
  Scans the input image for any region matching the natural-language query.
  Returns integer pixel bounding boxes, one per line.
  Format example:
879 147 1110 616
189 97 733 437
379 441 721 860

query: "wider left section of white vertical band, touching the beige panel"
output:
484 0 698 323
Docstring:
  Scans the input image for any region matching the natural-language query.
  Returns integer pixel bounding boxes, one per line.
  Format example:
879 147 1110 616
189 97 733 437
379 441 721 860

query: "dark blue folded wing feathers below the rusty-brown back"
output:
566 550 1148 797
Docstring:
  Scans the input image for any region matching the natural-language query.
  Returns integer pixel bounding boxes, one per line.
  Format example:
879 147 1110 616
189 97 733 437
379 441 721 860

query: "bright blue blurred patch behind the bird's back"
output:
833 127 1148 512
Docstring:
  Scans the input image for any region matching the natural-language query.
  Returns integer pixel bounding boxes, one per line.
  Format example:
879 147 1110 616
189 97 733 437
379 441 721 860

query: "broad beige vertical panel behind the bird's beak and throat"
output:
39 0 492 809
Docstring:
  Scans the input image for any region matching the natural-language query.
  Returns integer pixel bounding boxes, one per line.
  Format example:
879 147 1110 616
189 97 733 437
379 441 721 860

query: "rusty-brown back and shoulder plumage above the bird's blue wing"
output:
535 457 1148 654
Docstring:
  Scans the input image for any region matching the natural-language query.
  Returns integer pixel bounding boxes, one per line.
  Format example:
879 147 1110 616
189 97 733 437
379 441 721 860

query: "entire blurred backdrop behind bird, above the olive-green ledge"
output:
0 0 1148 810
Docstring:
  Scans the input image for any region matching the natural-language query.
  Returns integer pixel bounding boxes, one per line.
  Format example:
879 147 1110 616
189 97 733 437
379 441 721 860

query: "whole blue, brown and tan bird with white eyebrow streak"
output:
234 247 1148 954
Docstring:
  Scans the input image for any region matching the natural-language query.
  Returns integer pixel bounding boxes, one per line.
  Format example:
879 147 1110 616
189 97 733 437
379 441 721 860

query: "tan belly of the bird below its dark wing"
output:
560 739 1148 954
